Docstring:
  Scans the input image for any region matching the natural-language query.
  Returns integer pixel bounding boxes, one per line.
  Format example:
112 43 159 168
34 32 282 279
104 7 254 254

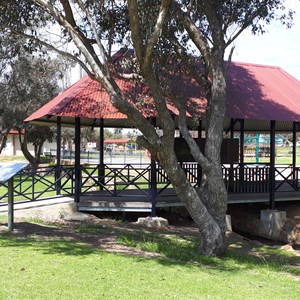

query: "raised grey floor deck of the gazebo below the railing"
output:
77 189 300 212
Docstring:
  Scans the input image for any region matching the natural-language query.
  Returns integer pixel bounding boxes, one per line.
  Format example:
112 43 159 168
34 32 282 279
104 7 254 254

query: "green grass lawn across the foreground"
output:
0 219 300 299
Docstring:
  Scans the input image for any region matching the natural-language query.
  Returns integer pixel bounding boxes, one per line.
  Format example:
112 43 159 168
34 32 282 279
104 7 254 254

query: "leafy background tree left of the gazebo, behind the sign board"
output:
0 44 68 163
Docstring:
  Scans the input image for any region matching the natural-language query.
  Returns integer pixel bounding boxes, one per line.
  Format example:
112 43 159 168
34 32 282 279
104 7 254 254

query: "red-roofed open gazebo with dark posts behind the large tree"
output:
25 56 300 215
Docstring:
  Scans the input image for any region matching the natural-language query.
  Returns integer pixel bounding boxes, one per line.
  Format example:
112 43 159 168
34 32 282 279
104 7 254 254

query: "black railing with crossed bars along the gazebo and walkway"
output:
0 163 300 202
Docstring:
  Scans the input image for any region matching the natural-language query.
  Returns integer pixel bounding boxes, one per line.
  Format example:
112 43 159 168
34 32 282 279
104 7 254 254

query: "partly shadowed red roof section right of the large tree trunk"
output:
226 62 300 121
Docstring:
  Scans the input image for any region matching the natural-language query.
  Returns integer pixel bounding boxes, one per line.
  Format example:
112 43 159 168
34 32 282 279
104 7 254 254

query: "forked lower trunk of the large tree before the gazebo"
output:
152 55 227 256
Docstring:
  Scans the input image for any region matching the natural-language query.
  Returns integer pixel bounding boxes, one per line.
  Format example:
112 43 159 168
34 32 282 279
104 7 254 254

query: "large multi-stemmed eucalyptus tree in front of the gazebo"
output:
0 0 291 255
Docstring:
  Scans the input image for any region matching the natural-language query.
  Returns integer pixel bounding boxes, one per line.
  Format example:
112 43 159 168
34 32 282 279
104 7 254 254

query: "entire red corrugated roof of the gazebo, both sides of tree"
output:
25 55 300 131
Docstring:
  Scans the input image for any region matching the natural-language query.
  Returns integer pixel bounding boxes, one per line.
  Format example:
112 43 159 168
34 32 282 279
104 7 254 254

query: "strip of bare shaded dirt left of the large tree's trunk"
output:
0 217 198 257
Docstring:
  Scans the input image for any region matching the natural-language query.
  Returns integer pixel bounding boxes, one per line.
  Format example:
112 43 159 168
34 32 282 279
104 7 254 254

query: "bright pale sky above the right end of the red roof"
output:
229 0 300 80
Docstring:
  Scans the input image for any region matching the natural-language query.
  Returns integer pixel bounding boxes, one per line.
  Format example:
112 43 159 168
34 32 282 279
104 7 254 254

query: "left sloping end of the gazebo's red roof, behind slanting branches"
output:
25 75 185 122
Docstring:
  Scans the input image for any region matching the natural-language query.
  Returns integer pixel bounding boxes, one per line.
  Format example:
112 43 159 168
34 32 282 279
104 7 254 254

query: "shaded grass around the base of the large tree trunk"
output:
118 232 300 276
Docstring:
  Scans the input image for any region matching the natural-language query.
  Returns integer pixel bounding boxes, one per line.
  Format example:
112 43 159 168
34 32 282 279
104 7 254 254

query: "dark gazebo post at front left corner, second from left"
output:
74 117 81 203
